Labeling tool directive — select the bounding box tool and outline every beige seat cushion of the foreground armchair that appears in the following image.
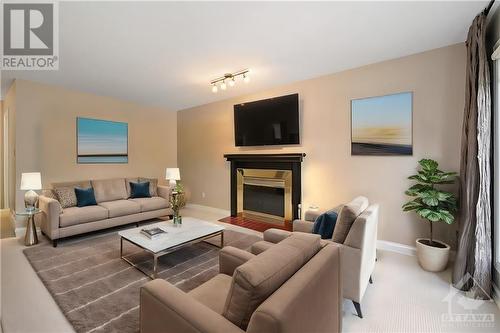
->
[189,274,233,314]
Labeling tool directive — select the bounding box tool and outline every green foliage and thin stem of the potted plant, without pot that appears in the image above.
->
[402,159,457,246]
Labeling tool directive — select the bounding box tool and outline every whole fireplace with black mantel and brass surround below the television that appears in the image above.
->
[224,153,305,222]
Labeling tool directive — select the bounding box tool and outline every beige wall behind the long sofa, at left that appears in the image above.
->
[16,80,177,209]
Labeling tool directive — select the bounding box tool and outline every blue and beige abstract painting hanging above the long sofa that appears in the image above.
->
[76,118,128,164]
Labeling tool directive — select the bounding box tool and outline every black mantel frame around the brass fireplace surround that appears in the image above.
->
[224,153,306,220]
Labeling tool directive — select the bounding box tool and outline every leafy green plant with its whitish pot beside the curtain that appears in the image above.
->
[402,159,457,272]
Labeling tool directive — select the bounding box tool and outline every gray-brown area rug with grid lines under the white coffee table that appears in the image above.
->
[24,223,260,332]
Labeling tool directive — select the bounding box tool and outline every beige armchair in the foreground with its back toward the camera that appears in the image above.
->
[140,233,342,333]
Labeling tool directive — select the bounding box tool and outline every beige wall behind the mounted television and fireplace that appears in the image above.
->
[177,44,465,245]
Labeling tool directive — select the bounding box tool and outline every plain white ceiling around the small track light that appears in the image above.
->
[1,1,487,111]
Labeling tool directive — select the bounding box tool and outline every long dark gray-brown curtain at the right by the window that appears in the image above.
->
[453,12,492,299]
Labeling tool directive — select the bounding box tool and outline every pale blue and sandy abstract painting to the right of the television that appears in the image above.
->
[351,92,413,155]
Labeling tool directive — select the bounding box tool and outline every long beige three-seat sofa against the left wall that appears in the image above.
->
[37,178,173,247]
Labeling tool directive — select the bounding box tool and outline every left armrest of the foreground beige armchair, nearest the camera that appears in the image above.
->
[140,279,243,333]
